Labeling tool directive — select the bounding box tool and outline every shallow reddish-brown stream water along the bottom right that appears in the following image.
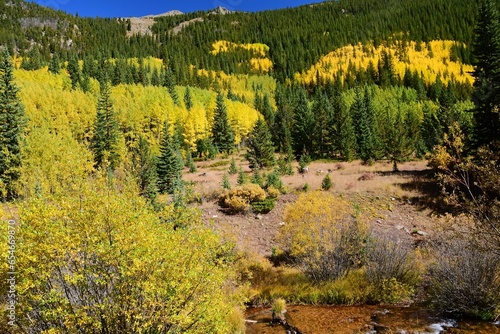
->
[246,305,500,334]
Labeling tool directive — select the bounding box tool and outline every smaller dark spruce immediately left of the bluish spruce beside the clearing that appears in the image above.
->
[132,136,158,203]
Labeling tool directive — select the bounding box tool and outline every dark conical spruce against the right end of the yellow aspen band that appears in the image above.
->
[211,92,234,153]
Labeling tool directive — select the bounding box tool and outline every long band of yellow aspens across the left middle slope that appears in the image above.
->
[15,68,260,156]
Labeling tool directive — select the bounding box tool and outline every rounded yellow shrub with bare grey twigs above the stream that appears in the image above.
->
[277,191,366,282]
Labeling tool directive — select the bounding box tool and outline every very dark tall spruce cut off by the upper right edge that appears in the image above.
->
[473,0,500,148]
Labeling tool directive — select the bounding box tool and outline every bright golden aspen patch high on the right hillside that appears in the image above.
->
[295,40,474,84]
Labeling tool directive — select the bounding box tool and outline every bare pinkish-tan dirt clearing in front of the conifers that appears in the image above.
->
[184,156,434,256]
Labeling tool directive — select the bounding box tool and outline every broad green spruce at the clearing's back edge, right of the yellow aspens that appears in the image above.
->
[246,118,275,169]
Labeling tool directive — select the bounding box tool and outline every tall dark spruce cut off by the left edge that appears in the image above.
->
[0,48,26,199]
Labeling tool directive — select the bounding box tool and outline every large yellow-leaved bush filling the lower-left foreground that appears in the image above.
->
[11,175,241,333]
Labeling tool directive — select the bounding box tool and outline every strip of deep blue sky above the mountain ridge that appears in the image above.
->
[31,0,321,17]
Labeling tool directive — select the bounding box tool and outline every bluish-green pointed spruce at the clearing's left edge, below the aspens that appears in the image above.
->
[156,121,182,194]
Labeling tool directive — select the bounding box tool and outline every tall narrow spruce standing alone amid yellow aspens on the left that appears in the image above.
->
[90,82,120,170]
